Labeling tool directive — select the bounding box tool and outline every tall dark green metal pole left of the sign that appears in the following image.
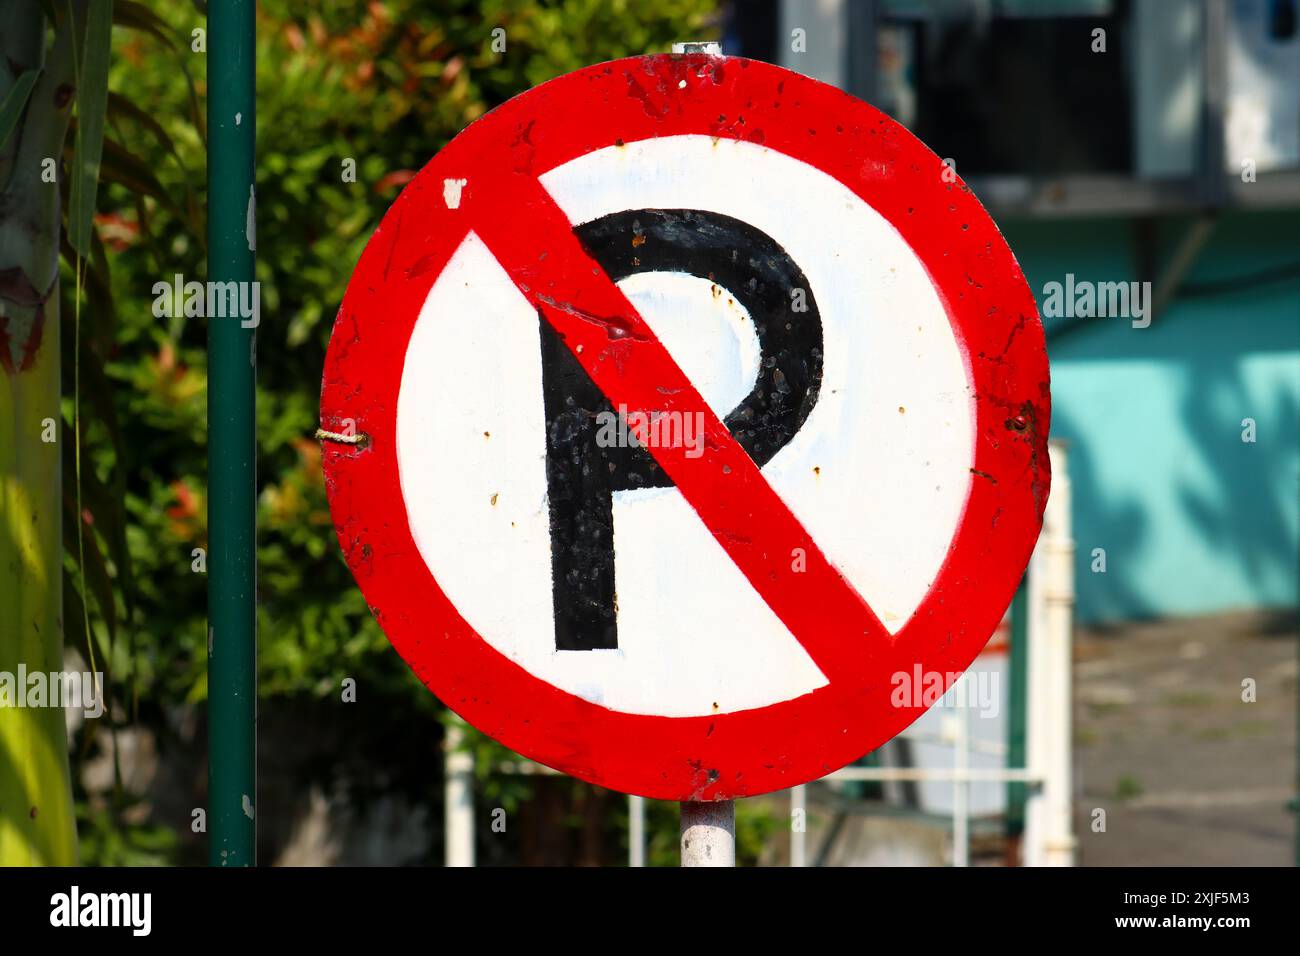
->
[208,0,257,866]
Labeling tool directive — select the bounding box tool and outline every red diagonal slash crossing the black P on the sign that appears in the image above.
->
[473,176,892,684]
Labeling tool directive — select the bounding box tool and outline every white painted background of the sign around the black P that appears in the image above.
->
[397,135,974,717]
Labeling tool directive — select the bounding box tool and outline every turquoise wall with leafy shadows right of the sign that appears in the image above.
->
[1002,212,1300,622]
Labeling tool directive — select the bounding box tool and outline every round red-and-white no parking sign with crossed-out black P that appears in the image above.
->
[321,55,1049,800]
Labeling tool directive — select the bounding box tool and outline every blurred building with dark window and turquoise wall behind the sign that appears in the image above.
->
[724,0,1300,622]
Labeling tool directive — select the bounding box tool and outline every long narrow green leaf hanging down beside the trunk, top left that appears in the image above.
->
[68,0,113,259]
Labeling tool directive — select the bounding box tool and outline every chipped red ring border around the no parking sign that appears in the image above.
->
[321,55,1050,800]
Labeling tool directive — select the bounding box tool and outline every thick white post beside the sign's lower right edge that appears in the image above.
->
[1024,442,1075,866]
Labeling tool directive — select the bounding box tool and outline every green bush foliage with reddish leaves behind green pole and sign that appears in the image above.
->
[64,0,790,864]
